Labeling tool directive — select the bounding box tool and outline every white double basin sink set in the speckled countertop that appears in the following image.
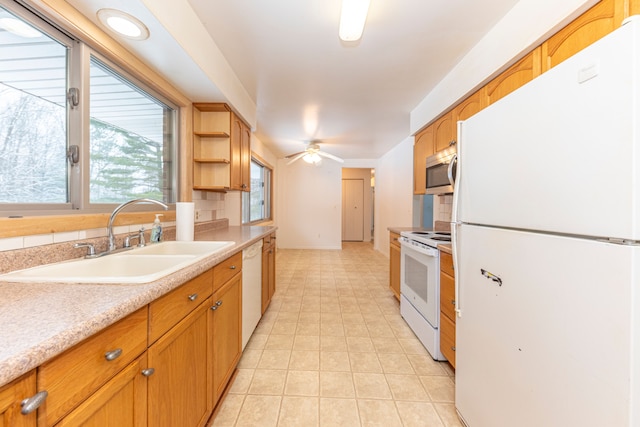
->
[0,241,235,284]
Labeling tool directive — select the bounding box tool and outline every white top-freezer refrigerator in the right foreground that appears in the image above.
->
[452,18,640,427]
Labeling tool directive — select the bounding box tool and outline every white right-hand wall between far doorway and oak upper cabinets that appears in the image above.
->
[374,137,413,256]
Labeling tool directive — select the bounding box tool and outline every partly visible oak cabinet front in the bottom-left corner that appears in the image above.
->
[0,371,36,427]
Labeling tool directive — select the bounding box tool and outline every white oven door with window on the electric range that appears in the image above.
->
[400,240,440,329]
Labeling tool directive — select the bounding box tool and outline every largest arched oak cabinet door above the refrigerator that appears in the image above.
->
[542,0,624,71]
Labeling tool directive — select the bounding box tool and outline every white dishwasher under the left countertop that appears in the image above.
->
[242,239,262,350]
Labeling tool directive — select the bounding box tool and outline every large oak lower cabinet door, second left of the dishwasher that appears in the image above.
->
[148,298,213,427]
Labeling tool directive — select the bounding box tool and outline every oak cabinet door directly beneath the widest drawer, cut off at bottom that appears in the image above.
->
[56,353,147,427]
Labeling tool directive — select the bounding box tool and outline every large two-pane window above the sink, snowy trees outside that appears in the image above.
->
[0,0,177,216]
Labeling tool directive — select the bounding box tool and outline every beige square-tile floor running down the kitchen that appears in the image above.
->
[211,243,461,427]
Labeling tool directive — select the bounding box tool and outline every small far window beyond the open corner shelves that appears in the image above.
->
[242,156,272,224]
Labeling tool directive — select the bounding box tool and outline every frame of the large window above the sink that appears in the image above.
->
[0,0,180,217]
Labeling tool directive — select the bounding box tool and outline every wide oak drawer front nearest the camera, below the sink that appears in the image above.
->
[38,306,147,426]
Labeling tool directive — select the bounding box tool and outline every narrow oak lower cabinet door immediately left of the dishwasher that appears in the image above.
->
[212,274,242,402]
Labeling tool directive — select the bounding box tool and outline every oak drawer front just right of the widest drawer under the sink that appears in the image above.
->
[149,270,213,343]
